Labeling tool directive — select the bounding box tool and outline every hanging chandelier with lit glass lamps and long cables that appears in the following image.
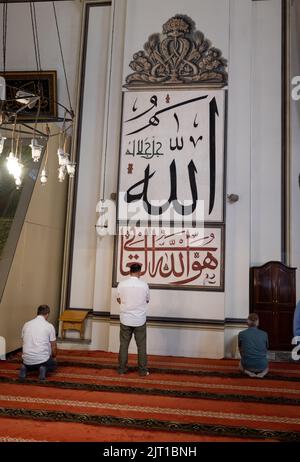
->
[0,2,76,189]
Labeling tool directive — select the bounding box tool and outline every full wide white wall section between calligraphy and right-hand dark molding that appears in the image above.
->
[225,0,281,319]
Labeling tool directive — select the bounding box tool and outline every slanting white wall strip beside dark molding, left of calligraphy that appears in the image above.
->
[70,6,111,308]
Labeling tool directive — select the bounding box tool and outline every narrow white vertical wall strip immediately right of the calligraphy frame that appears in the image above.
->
[225,0,253,318]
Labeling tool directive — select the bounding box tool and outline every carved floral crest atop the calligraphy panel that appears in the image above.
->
[126,15,227,86]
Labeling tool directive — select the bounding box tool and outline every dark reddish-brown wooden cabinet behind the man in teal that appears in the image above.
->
[250,261,296,350]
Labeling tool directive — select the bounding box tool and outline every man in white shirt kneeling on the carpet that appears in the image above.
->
[19,305,57,381]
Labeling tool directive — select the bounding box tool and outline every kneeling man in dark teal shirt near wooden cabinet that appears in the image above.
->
[238,313,269,378]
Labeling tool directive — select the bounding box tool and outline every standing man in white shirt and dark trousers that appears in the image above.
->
[117,263,150,376]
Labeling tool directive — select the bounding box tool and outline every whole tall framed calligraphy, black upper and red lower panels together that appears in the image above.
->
[114,88,226,291]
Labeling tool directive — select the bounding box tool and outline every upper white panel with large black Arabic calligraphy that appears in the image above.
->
[118,89,225,223]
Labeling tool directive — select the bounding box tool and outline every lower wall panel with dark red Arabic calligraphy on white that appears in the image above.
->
[115,225,224,291]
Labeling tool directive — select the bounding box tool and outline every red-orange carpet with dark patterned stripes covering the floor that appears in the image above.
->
[0,350,300,442]
